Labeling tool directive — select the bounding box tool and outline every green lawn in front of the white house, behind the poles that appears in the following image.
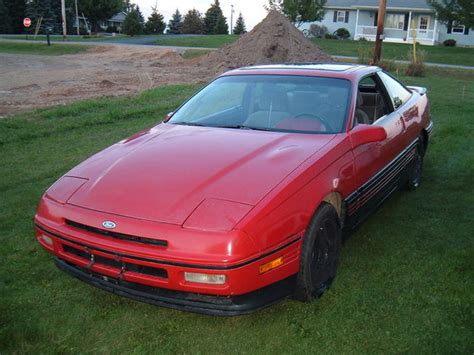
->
[312,38,474,66]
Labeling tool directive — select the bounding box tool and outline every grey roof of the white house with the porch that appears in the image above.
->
[326,0,434,12]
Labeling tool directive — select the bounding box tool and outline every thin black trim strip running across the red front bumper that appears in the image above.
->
[35,223,301,270]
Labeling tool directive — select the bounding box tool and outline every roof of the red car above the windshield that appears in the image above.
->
[222,63,381,80]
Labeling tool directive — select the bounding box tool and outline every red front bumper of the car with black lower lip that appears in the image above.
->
[35,207,301,316]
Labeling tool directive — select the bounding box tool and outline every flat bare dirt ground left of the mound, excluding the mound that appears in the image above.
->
[0,45,214,116]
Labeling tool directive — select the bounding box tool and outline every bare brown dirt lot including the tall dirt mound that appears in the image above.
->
[0,12,333,117]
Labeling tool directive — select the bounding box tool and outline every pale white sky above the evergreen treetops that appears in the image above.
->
[134,0,268,31]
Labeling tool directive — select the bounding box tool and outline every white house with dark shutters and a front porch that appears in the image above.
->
[301,0,474,46]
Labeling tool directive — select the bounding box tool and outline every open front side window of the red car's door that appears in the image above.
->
[354,75,390,126]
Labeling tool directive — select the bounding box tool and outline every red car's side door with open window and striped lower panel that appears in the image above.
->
[348,74,405,225]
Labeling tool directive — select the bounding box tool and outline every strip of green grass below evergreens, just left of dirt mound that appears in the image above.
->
[155,35,239,48]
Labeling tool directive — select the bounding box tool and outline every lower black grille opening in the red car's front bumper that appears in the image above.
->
[63,244,168,279]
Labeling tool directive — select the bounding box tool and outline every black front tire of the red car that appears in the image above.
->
[295,203,342,302]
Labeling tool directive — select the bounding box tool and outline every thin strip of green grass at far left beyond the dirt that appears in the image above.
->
[0,41,91,55]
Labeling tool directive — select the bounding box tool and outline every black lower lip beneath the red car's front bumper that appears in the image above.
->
[55,258,296,316]
